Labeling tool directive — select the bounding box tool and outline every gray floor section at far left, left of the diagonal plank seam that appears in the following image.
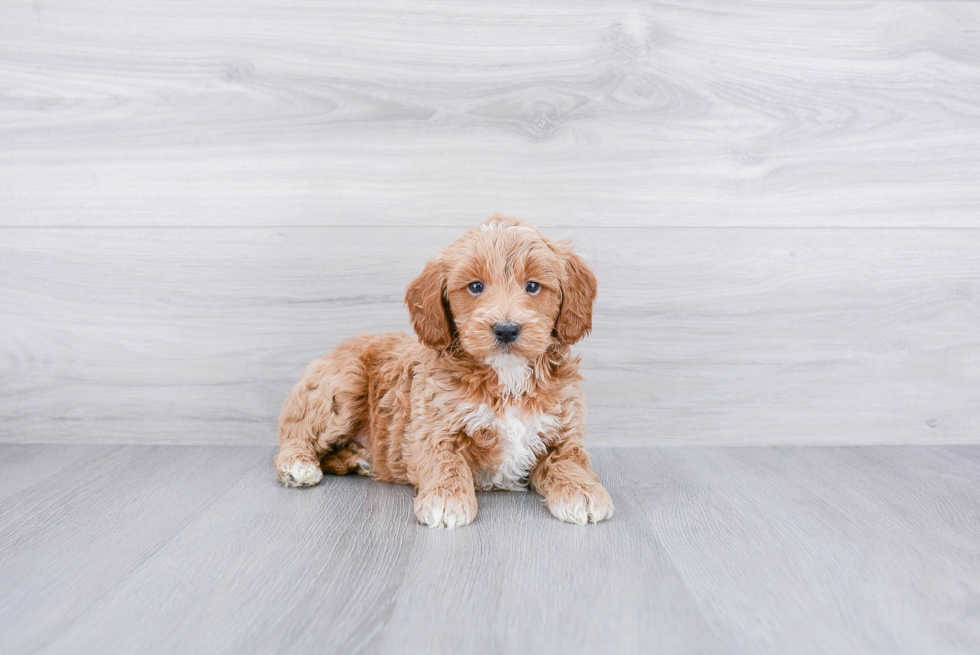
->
[0,446,268,653]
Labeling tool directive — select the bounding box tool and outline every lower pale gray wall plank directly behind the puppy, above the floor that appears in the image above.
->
[0,228,980,445]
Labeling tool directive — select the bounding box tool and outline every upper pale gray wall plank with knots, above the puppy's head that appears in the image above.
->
[0,0,980,227]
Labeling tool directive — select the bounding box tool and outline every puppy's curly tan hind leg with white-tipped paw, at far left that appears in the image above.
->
[275,342,367,487]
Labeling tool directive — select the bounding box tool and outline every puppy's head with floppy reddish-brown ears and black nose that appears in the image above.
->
[405,215,596,362]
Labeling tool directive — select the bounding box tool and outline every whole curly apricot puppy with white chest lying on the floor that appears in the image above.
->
[275,214,613,528]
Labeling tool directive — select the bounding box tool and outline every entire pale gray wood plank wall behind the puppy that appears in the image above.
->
[0,0,980,445]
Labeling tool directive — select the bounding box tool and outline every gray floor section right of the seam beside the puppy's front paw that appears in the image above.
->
[615,448,980,653]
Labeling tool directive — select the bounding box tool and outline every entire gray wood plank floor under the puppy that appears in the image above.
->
[0,445,980,655]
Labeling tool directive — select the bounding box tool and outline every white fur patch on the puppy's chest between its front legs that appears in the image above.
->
[464,405,558,491]
